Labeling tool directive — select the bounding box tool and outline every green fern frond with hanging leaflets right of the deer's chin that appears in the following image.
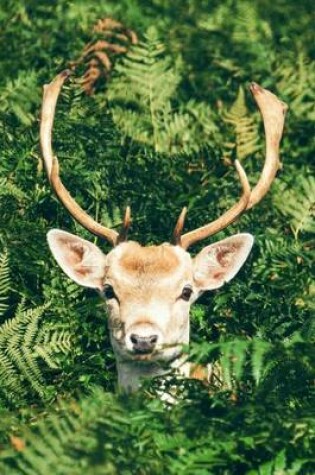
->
[189,333,315,402]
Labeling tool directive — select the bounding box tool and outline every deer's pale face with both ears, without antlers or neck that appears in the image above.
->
[48,230,253,362]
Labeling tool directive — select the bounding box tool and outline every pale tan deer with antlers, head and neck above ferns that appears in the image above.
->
[40,71,287,392]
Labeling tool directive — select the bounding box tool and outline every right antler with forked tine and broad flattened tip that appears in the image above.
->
[178,83,288,249]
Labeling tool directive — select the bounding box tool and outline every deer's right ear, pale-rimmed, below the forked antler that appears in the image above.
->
[193,234,254,292]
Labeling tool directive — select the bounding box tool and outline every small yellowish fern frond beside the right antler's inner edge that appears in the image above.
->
[223,87,259,164]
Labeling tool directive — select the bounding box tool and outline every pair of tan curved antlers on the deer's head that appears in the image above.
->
[40,71,287,249]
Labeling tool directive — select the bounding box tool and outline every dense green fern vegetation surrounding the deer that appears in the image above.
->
[0,0,315,475]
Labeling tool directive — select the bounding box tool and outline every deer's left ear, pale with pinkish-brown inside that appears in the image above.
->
[47,229,106,290]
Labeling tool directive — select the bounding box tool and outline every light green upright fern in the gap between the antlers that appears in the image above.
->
[108,28,216,153]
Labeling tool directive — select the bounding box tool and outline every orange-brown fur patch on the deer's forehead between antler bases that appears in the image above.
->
[120,243,180,274]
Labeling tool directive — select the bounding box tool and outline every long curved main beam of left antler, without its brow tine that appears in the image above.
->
[40,71,119,246]
